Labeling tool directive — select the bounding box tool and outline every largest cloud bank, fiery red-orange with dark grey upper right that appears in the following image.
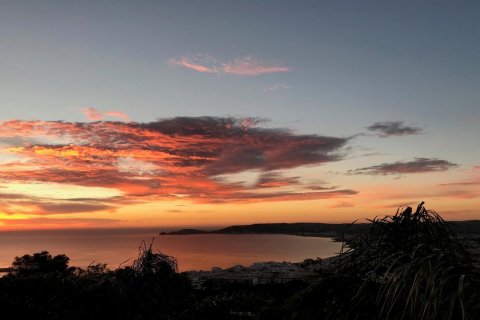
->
[0,117,356,214]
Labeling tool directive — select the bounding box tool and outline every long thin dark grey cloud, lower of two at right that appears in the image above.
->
[349,158,458,175]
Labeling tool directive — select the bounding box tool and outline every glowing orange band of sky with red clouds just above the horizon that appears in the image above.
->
[0,117,480,230]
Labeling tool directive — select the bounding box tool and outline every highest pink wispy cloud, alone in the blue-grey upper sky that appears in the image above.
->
[169,55,291,76]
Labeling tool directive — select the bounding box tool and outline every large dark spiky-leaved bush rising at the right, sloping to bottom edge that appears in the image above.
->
[283,202,480,320]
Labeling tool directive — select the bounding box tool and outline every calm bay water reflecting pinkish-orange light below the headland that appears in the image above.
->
[0,229,341,271]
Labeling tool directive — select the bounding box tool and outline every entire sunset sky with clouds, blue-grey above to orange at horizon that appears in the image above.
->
[0,0,480,230]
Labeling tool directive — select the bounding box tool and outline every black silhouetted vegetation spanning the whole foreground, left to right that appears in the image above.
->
[0,203,480,320]
